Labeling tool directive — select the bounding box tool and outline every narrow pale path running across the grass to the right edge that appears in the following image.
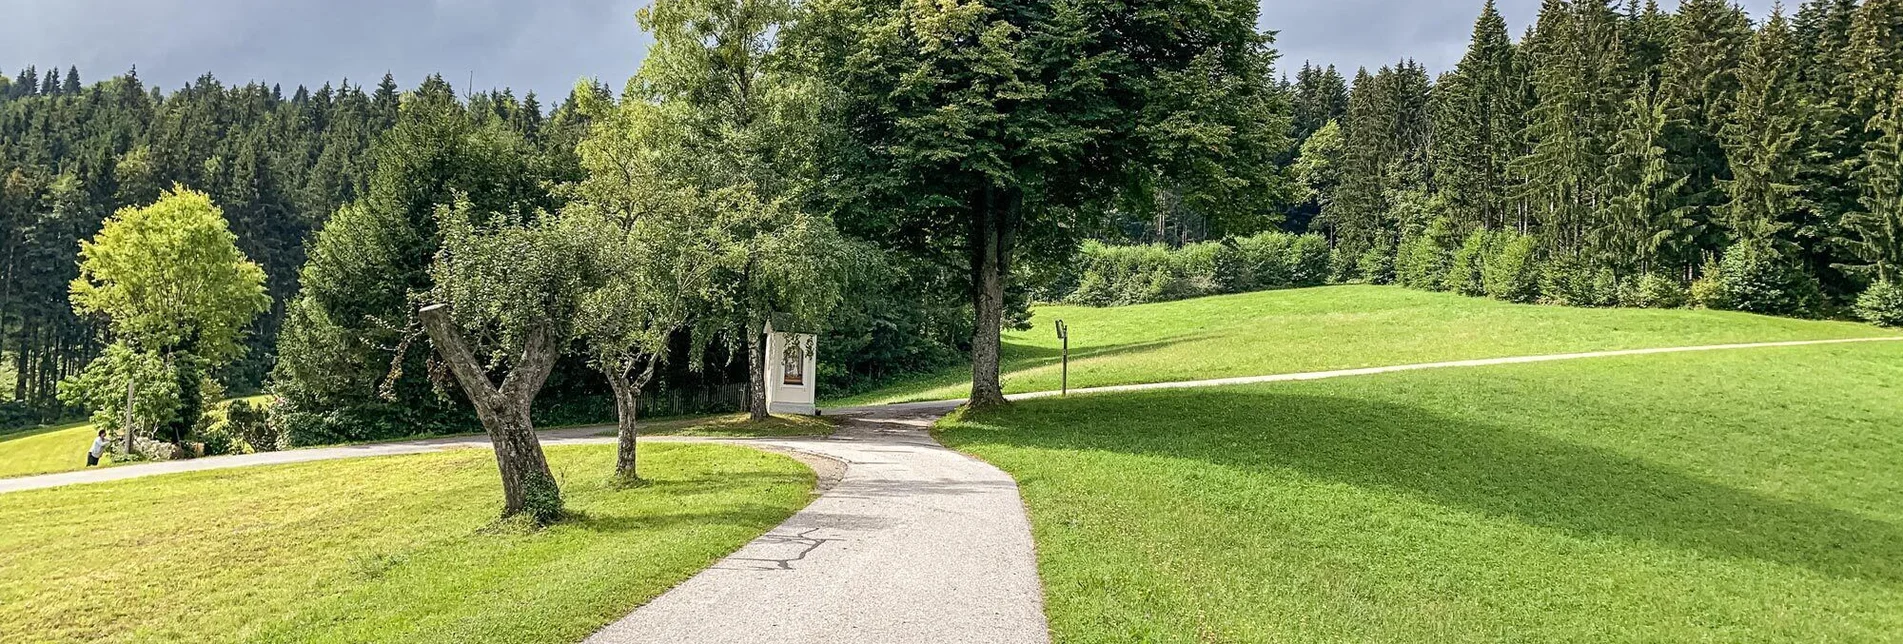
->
[824,335,1903,415]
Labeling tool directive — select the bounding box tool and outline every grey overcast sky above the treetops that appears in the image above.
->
[0,0,1796,105]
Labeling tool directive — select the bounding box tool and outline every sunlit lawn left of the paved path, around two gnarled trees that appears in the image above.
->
[0,444,813,642]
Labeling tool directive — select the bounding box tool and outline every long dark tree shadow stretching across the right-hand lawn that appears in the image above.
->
[946,391,1903,583]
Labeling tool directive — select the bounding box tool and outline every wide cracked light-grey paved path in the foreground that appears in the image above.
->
[586,406,1049,644]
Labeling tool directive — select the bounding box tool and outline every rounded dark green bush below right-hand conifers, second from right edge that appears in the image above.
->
[1694,242,1823,316]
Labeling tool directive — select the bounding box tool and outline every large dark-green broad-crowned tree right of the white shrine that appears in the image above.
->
[794,0,1288,406]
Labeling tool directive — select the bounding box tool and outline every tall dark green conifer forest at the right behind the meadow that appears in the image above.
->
[1286,0,1903,314]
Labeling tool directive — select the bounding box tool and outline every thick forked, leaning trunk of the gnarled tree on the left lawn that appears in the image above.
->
[421,305,561,522]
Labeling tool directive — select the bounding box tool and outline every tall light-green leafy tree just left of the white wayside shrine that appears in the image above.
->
[627,0,843,421]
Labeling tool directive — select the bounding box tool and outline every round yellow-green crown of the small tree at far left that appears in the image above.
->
[72,189,270,366]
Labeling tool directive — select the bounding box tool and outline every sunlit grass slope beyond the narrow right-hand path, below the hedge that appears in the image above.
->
[826,286,1895,406]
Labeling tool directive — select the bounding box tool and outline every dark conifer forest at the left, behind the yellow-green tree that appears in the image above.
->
[0,67,586,423]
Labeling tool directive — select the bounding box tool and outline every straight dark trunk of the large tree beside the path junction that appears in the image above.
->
[969,187,1018,408]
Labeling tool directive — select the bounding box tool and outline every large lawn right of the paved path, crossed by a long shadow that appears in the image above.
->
[940,337,1903,642]
